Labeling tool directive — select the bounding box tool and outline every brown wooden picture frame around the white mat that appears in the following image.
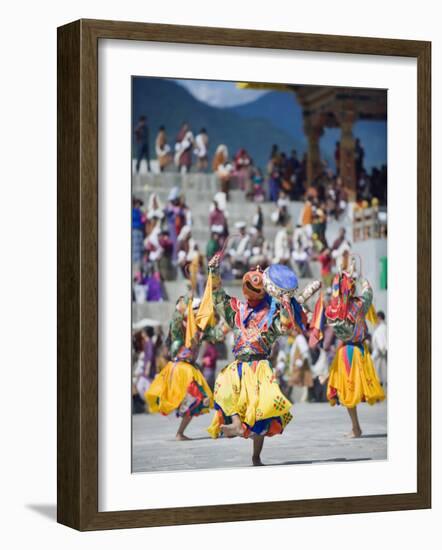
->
[57,20,431,531]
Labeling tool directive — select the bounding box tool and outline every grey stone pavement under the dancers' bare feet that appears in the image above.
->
[132,402,387,472]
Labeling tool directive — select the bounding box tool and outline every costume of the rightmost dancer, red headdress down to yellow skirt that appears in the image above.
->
[325,273,385,408]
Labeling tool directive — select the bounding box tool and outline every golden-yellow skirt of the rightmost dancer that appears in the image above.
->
[327,344,385,409]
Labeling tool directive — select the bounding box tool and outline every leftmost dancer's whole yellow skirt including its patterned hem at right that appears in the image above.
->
[145,361,213,416]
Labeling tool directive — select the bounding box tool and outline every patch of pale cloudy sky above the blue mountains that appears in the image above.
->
[175,80,267,107]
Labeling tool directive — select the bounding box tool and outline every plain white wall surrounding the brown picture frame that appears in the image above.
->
[0,0,442,550]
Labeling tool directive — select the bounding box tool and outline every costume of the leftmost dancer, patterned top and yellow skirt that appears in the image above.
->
[145,297,214,417]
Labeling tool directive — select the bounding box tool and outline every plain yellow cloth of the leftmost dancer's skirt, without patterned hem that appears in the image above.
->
[145,361,213,414]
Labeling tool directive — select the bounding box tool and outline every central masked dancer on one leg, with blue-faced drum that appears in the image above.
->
[203,253,322,466]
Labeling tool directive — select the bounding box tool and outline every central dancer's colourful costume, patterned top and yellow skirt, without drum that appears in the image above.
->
[208,267,302,438]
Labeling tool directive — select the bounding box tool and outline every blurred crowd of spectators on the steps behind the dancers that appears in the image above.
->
[132,119,387,410]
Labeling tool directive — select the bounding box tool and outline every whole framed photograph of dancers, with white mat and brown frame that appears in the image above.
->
[57,20,431,530]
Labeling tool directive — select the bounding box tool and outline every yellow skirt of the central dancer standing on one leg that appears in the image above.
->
[207,360,293,438]
